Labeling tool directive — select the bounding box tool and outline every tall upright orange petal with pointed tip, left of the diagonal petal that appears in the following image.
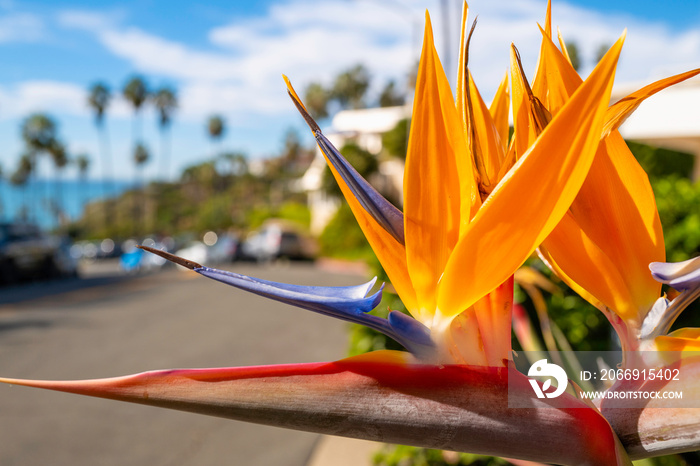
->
[404,15,470,313]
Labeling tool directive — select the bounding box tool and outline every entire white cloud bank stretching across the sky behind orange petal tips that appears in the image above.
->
[53,0,700,127]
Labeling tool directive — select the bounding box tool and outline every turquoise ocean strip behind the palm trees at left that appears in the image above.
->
[0,179,133,230]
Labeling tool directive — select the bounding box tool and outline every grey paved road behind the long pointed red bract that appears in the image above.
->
[0,264,361,466]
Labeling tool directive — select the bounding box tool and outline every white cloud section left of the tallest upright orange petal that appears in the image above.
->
[60,0,417,118]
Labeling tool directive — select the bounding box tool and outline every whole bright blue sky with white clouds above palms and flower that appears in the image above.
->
[0,0,700,179]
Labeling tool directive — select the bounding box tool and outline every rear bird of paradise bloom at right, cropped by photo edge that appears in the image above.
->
[514,6,700,447]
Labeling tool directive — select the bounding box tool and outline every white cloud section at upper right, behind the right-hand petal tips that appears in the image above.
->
[448,0,700,94]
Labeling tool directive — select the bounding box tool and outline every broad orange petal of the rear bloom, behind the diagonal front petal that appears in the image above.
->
[543,131,665,326]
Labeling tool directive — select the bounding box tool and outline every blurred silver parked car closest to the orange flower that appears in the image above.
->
[241,221,318,262]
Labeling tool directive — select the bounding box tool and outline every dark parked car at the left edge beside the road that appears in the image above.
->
[0,222,77,284]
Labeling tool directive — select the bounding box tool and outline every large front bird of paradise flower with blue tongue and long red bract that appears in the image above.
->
[2,1,700,464]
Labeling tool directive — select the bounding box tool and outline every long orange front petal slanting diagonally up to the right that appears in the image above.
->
[438,31,623,318]
